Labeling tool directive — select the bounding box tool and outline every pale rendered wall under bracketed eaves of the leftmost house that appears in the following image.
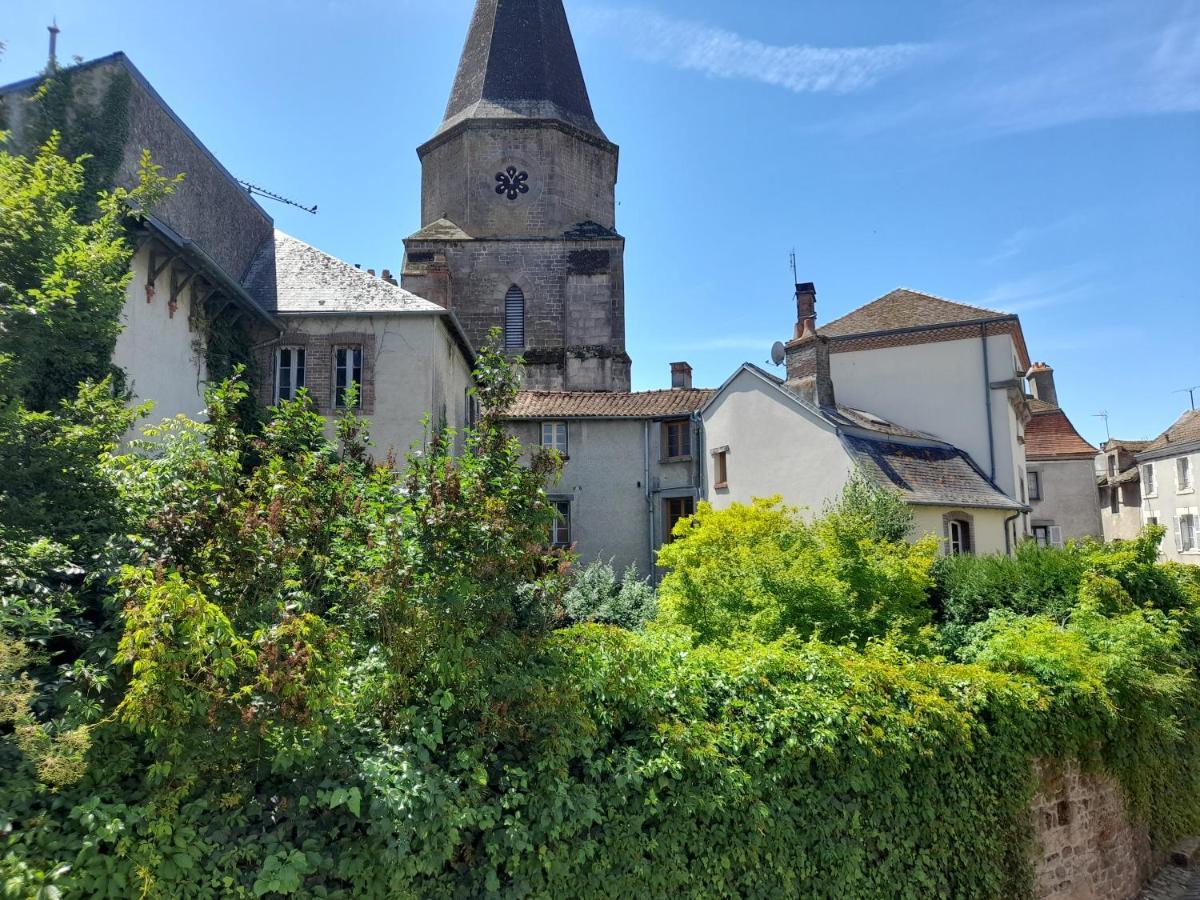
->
[113,246,208,432]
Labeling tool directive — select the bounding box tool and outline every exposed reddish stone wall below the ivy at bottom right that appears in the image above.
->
[1032,761,1154,900]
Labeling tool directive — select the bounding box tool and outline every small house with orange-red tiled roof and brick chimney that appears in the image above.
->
[1025,362,1103,547]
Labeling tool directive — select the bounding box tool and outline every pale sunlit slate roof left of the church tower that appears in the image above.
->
[244,229,445,314]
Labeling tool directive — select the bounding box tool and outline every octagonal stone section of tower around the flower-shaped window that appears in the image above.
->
[421,121,617,238]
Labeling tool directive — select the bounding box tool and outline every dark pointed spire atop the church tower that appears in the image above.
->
[438,0,607,140]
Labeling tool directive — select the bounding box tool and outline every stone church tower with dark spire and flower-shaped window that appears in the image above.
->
[403,0,630,391]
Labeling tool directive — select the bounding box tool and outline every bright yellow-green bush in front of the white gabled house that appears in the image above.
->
[659,488,937,646]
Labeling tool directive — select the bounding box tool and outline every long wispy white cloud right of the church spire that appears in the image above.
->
[580,7,929,94]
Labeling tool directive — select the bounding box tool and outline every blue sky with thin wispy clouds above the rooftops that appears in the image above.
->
[0,0,1200,442]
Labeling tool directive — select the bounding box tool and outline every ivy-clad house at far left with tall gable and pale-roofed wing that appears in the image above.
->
[0,53,474,457]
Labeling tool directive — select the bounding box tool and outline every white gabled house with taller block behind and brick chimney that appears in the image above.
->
[701,283,1028,553]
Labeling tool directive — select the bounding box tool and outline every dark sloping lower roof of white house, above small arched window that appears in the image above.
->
[842,436,1025,511]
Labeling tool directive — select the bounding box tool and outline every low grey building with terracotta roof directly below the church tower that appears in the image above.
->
[509,362,713,578]
